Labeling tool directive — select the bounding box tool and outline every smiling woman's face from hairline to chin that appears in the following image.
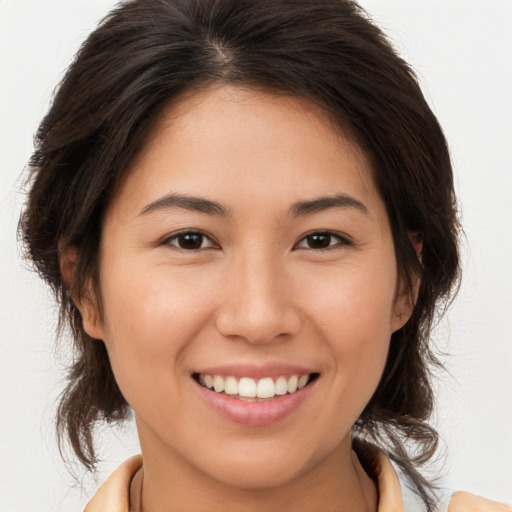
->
[84,86,407,487]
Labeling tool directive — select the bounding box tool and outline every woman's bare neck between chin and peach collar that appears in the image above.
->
[130,436,378,512]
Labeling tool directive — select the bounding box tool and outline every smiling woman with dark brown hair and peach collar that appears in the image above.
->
[18,0,510,512]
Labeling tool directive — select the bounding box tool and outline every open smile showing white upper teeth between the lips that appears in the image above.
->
[192,373,320,402]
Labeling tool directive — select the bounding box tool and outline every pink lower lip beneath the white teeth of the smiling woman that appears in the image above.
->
[193,380,316,427]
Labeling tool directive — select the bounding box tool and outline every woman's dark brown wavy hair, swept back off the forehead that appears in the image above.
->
[20,0,459,510]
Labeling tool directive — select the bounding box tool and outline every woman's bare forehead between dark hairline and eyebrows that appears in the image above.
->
[111,85,377,217]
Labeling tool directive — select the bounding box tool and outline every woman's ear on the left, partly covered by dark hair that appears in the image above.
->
[60,247,104,339]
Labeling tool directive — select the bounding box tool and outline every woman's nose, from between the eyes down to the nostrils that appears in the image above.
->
[216,249,301,344]
